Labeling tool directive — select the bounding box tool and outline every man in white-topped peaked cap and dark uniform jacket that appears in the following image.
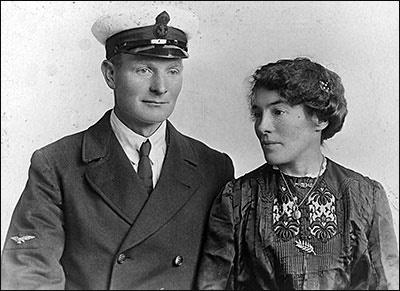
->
[2,7,233,289]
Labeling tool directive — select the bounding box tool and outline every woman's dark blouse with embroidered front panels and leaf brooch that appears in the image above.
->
[197,158,399,290]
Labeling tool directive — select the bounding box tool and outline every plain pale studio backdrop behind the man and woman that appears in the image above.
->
[1,1,399,248]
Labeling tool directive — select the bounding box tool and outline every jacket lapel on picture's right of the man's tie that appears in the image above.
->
[120,121,202,251]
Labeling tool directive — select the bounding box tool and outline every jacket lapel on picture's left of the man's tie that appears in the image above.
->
[82,111,147,224]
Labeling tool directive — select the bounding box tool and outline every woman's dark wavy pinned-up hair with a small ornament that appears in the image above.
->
[248,58,347,142]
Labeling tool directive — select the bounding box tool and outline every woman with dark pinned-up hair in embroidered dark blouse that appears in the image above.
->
[198,58,398,290]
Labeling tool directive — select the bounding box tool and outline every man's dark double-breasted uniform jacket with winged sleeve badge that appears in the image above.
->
[1,111,233,290]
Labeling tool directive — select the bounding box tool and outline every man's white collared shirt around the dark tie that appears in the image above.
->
[110,109,167,187]
